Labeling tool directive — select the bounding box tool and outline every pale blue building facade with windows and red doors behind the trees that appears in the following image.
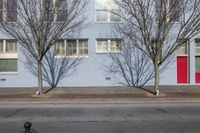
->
[0,0,200,88]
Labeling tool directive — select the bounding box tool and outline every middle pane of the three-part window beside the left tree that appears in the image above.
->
[67,40,77,56]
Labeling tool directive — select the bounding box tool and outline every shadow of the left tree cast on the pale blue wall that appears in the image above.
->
[23,49,83,90]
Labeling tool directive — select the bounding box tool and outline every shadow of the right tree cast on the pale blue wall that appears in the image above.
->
[104,40,154,88]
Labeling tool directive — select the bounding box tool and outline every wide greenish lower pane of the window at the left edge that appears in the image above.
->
[0,59,17,72]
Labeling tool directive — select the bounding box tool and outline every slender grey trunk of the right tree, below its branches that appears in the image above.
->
[154,62,160,96]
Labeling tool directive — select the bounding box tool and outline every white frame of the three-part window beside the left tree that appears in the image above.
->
[56,39,89,58]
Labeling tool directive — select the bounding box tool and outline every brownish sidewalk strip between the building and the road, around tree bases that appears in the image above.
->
[0,86,200,102]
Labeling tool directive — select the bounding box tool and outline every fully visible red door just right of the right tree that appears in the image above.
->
[177,56,188,83]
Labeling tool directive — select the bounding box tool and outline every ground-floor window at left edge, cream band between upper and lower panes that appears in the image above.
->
[0,40,17,72]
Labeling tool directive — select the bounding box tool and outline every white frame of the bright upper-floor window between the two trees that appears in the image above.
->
[95,0,122,23]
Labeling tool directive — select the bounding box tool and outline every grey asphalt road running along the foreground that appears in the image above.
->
[0,103,200,133]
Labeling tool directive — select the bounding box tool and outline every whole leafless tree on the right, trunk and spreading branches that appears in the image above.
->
[110,0,200,95]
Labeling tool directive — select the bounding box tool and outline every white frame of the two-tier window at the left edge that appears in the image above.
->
[0,39,18,74]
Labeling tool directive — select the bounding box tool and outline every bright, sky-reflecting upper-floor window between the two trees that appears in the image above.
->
[96,0,121,22]
